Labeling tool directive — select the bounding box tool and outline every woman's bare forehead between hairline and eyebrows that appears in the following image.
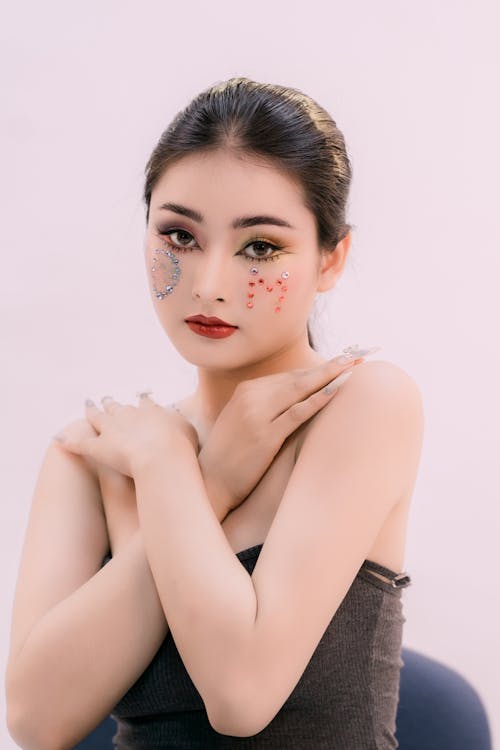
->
[151,151,314,227]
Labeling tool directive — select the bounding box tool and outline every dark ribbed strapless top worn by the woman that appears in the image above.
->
[106,544,411,750]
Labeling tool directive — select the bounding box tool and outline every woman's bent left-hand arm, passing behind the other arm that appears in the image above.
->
[6,420,232,750]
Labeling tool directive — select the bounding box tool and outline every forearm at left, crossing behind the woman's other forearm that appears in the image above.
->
[7,531,168,750]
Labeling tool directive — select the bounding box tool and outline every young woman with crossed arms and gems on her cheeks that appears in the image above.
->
[7,78,423,750]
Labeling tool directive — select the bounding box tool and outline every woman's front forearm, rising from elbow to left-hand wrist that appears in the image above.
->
[133,439,256,717]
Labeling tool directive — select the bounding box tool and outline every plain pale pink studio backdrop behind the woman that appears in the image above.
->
[0,0,500,750]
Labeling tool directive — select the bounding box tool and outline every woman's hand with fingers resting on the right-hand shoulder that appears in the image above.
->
[198,347,379,513]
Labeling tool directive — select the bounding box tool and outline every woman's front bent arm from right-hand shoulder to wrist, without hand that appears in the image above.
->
[133,362,422,736]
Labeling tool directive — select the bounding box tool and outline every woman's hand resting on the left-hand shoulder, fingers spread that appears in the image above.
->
[52,394,198,477]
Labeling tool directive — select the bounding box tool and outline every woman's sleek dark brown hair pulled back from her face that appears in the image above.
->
[143,77,352,349]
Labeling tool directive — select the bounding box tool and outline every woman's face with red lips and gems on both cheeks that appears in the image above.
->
[145,150,328,369]
